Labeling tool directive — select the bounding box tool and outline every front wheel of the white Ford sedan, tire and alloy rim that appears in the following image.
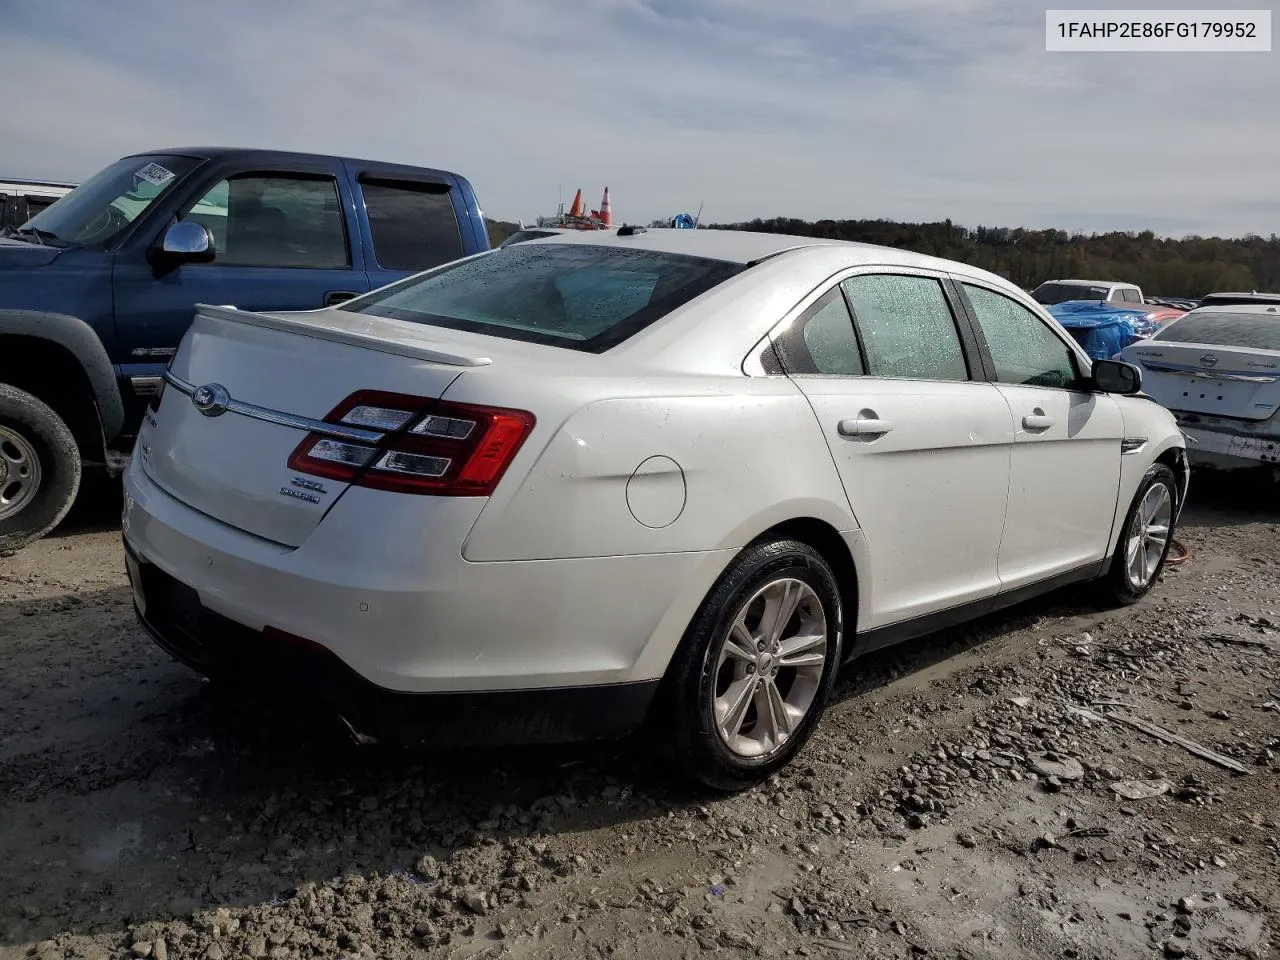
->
[1098,463,1179,607]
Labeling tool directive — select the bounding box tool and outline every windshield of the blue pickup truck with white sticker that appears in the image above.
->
[18,156,200,250]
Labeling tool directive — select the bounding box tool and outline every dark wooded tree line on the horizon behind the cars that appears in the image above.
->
[709,216,1280,297]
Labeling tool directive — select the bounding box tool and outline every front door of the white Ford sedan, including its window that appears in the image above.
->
[957,278,1124,590]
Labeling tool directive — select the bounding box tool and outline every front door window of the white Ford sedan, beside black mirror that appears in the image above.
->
[964,283,1080,389]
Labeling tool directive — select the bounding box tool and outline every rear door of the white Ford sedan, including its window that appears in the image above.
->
[774,270,1014,630]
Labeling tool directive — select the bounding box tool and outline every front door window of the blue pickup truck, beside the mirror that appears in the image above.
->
[183,174,351,269]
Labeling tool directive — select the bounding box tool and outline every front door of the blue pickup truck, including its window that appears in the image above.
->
[114,161,369,401]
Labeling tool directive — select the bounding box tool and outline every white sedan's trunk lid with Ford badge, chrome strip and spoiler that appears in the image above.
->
[138,305,490,547]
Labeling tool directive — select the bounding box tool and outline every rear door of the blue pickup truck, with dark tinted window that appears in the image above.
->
[348,164,466,288]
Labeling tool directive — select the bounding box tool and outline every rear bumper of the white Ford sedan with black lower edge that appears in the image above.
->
[123,460,727,740]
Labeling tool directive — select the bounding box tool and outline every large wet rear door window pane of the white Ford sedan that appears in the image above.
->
[842,274,969,380]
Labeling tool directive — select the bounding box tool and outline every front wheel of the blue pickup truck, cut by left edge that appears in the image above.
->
[0,384,81,550]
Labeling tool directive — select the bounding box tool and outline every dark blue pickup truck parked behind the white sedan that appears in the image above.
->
[0,147,489,550]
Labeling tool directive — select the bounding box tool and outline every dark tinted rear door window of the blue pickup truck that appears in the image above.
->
[360,177,462,271]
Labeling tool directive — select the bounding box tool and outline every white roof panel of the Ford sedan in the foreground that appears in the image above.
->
[519,228,986,273]
